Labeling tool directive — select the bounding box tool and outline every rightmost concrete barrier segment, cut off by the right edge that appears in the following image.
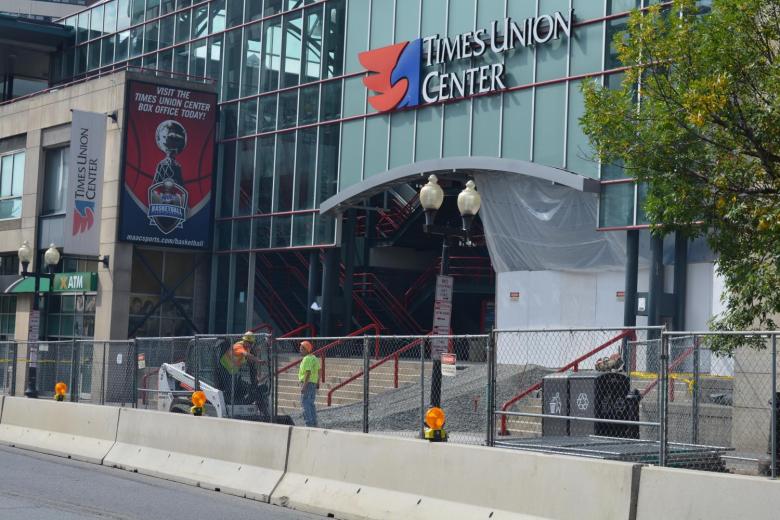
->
[637,466,780,520]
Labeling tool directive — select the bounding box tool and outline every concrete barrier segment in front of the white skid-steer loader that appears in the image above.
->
[104,408,290,502]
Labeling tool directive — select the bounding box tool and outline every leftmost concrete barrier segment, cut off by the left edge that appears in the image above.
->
[0,396,119,464]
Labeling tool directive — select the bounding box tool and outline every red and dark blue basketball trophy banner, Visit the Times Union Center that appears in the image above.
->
[119,81,217,249]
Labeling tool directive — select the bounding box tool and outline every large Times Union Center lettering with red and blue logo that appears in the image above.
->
[358,10,574,112]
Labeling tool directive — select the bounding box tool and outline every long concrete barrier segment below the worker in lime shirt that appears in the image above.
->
[271,428,640,520]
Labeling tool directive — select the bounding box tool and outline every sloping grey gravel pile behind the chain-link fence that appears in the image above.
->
[292,363,549,444]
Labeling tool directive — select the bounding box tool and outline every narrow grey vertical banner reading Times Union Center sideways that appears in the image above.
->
[63,110,106,256]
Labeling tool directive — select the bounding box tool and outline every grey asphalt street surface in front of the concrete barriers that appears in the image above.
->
[0,447,320,520]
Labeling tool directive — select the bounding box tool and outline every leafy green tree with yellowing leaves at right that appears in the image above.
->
[581,0,780,330]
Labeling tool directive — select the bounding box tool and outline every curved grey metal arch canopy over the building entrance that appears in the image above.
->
[320,157,599,214]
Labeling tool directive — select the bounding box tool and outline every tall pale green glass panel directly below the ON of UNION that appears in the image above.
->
[534,84,566,168]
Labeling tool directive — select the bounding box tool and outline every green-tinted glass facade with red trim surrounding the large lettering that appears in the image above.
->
[48,0,672,334]
